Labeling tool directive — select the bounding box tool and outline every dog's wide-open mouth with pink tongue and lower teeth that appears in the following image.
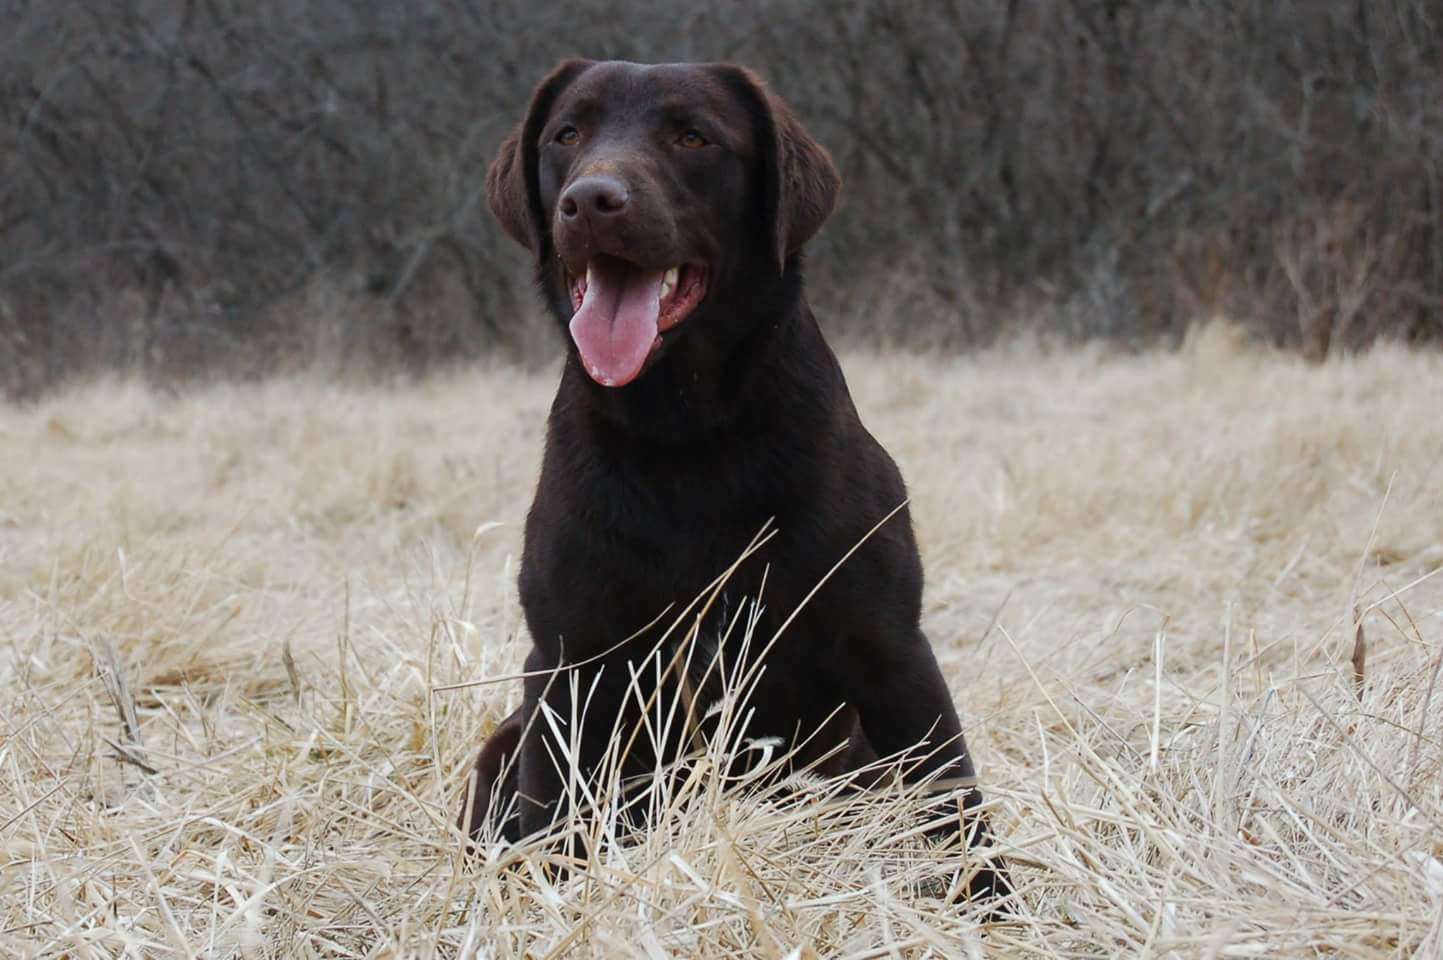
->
[567,256,707,387]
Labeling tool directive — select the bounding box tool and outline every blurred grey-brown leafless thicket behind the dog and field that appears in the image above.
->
[0,0,1443,398]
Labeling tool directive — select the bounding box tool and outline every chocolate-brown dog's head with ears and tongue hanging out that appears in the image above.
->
[486,61,840,387]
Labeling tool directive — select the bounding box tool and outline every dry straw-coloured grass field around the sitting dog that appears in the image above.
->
[0,331,1443,959]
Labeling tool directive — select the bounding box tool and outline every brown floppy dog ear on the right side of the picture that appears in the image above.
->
[719,64,841,270]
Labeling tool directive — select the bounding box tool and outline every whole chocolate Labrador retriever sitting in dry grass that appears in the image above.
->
[460,61,1006,895]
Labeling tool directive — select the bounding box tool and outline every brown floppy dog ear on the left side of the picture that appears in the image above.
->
[486,61,592,251]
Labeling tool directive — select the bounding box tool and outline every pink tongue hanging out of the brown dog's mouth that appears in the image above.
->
[571,257,662,387]
